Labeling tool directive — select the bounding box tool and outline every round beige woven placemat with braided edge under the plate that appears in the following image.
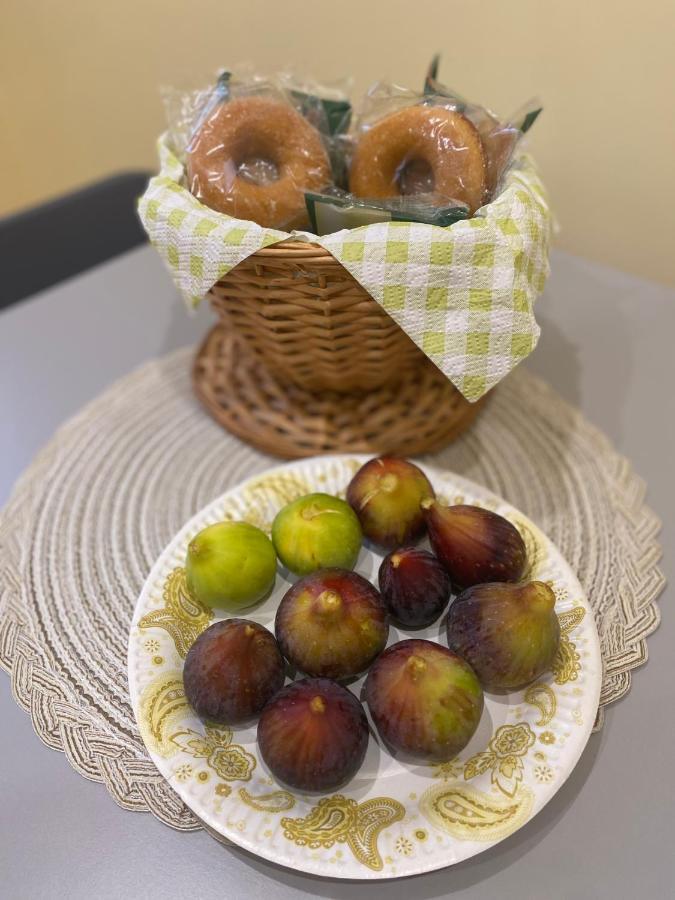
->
[0,350,664,829]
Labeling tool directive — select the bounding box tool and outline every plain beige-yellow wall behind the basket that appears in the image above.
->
[0,0,675,283]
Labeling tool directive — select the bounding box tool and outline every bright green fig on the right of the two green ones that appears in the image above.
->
[272,494,363,575]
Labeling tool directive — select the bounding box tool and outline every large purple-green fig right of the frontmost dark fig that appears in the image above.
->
[365,639,483,762]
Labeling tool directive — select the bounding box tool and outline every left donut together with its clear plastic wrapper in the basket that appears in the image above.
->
[171,72,338,230]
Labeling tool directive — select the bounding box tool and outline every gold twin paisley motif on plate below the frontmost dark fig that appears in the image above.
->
[281,794,405,872]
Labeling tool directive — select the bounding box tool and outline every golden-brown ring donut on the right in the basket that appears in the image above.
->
[349,106,485,214]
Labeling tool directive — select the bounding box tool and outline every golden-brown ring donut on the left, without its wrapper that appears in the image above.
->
[187,96,331,229]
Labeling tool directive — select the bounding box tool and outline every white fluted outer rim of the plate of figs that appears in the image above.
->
[127,453,604,881]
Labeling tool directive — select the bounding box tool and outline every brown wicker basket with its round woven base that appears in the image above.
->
[193,242,488,457]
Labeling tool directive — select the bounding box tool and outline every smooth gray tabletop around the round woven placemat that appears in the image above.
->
[0,247,675,900]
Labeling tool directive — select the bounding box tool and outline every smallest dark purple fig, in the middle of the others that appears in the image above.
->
[378,547,451,628]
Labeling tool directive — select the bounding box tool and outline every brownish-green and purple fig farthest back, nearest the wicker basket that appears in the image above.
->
[347,456,435,550]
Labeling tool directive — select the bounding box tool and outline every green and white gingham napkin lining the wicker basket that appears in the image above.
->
[138,136,552,401]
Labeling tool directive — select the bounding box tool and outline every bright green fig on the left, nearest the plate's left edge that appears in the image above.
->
[185,522,277,612]
